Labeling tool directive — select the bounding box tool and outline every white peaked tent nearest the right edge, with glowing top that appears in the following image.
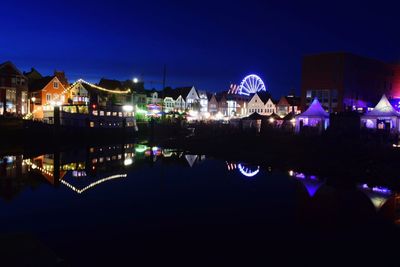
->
[361,95,400,133]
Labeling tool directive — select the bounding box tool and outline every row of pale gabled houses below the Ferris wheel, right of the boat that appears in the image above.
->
[134,86,300,117]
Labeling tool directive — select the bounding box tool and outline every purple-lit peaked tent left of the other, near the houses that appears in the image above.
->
[296,98,329,132]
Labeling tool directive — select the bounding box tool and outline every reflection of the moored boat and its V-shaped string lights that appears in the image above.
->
[24,144,135,194]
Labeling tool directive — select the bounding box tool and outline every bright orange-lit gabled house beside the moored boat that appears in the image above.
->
[28,76,68,119]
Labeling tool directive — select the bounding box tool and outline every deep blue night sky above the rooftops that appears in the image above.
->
[0,0,400,97]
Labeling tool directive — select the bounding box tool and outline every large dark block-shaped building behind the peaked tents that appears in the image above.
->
[301,52,400,112]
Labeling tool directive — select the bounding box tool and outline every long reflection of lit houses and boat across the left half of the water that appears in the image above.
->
[0,146,211,199]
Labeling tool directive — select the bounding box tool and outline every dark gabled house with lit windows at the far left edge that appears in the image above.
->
[0,61,29,115]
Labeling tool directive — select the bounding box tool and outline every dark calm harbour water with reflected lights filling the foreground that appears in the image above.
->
[0,144,400,266]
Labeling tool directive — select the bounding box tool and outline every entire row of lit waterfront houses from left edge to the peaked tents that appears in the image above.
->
[0,61,300,119]
